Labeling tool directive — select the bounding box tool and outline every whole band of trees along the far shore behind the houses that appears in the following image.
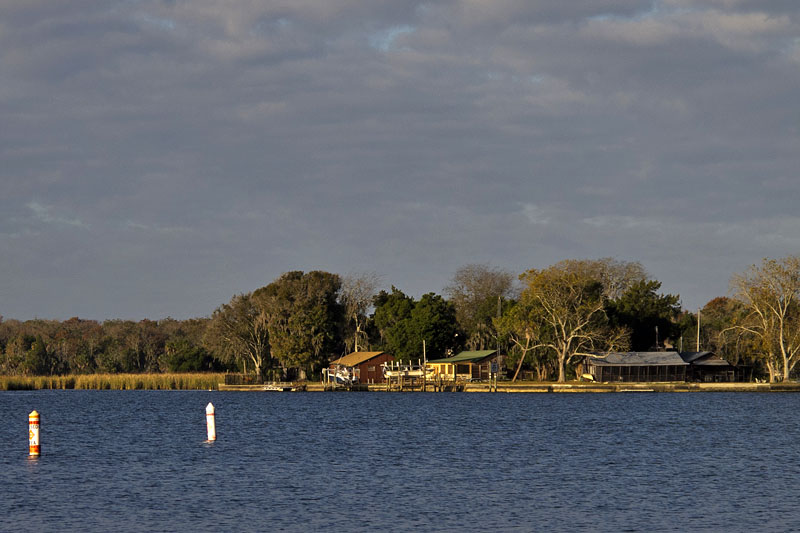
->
[0,256,800,381]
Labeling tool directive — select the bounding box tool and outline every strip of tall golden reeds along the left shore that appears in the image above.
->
[0,373,225,390]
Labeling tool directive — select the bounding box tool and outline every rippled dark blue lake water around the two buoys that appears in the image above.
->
[0,391,800,531]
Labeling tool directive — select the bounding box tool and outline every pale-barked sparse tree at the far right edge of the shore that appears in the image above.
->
[729,256,800,382]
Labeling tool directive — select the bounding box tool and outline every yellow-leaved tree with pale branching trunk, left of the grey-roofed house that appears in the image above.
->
[510,261,626,382]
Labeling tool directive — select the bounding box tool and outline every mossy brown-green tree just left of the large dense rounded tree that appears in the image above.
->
[203,294,271,376]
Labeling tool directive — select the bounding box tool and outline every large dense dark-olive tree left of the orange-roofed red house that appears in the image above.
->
[253,271,343,378]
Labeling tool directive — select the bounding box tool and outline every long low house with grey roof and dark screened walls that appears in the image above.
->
[578,351,691,381]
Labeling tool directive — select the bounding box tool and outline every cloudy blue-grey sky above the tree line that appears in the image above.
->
[0,0,800,320]
